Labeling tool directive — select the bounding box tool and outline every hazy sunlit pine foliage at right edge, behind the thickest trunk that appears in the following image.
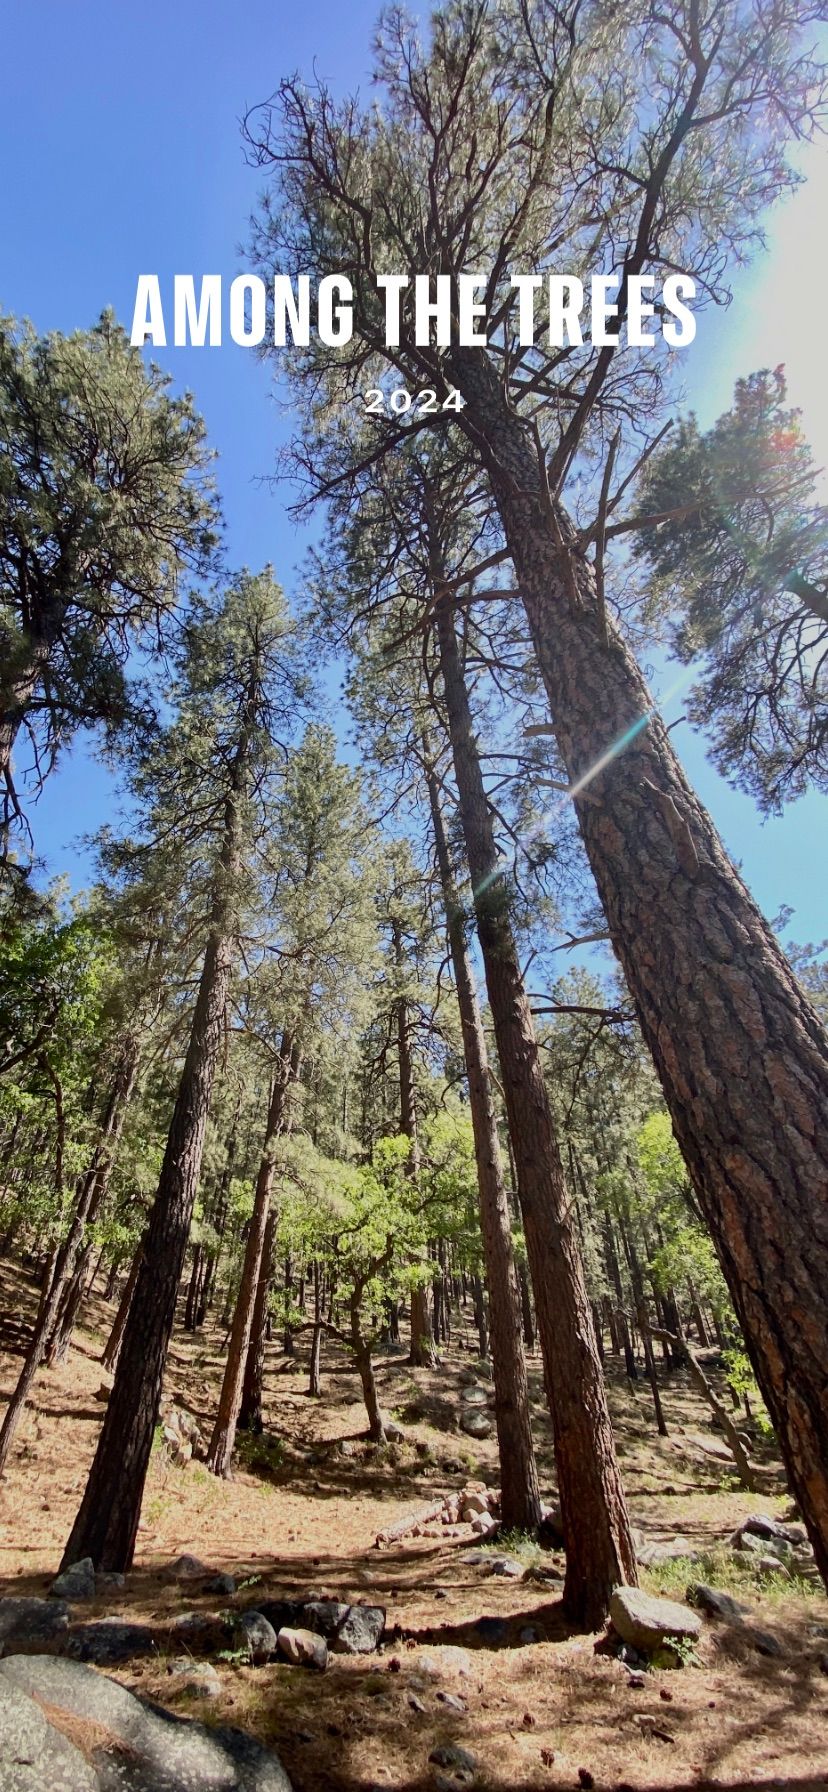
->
[634,367,828,812]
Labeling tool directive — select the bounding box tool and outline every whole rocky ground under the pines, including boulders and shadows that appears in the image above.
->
[0,1271,828,1792]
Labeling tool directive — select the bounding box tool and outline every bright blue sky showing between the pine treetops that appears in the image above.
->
[0,0,828,939]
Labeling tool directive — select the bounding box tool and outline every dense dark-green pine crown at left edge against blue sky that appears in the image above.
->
[0,312,217,824]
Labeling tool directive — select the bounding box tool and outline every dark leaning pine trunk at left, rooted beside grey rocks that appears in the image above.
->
[63,679,258,1572]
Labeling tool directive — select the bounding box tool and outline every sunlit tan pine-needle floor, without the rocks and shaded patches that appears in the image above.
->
[0,1265,828,1792]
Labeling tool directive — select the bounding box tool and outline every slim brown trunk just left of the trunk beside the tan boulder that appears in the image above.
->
[425,744,541,1530]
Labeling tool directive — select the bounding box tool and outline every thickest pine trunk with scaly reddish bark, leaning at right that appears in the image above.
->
[453,349,828,1581]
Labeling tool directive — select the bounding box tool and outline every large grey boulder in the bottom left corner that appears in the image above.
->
[0,1656,290,1792]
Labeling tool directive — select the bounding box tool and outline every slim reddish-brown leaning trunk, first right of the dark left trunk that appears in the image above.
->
[206,1032,299,1475]
